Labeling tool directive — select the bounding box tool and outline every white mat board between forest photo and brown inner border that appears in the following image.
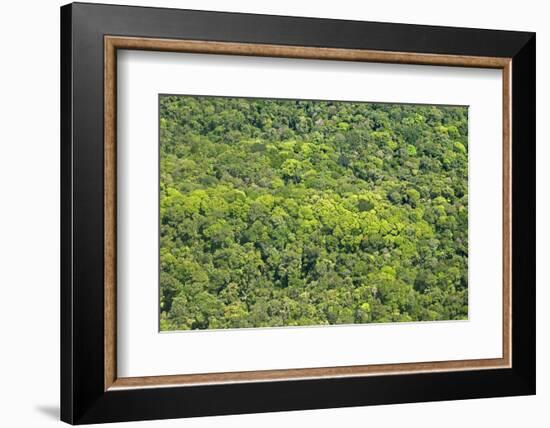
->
[117,51,502,377]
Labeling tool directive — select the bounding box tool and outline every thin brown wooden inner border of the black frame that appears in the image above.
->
[104,36,512,390]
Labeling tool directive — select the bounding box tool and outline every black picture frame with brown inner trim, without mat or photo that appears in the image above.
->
[61,3,535,424]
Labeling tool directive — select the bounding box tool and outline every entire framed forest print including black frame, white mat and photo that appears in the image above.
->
[61,3,535,424]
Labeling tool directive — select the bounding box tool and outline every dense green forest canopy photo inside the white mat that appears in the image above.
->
[160,96,468,330]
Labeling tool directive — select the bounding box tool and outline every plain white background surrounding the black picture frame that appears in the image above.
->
[0,0,550,428]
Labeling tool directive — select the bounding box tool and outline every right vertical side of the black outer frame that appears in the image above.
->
[511,33,536,395]
